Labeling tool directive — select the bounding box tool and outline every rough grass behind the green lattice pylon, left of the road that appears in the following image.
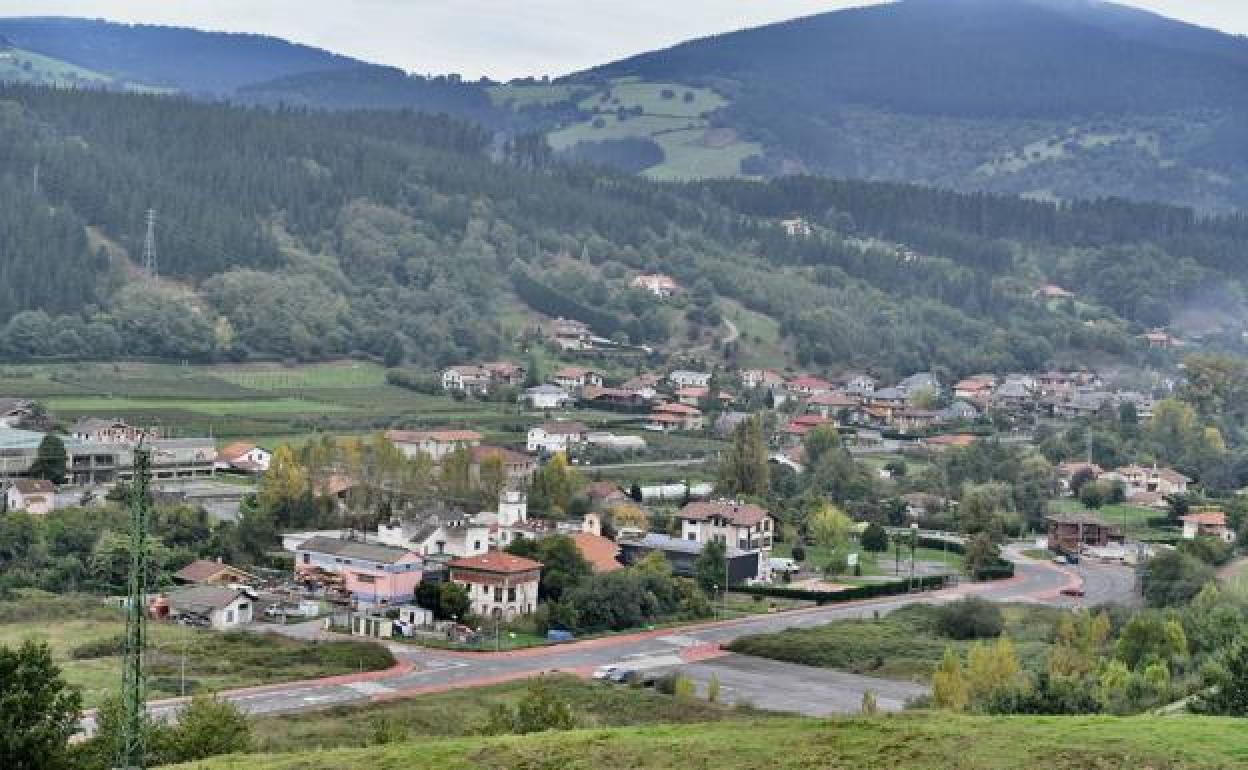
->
[0,597,393,708]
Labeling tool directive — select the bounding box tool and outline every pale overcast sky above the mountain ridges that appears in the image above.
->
[0,0,1248,79]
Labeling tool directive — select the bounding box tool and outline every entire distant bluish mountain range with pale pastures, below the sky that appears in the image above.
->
[7,0,1248,211]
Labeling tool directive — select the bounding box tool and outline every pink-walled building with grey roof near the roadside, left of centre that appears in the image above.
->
[295,537,424,604]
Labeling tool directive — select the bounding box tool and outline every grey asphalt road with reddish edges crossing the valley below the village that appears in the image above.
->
[84,546,1129,731]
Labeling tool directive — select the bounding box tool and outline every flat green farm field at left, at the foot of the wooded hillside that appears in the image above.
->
[0,362,673,452]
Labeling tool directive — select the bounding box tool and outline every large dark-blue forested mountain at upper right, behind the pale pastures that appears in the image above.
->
[570,0,1248,210]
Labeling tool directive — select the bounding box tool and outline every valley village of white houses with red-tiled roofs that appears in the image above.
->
[0,303,1236,648]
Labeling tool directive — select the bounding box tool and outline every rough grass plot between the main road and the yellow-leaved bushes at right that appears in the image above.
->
[729,604,1060,683]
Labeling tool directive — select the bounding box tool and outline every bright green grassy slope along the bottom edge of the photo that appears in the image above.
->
[170,714,1248,770]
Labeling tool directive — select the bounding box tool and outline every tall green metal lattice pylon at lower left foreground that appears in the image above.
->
[117,444,151,770]
